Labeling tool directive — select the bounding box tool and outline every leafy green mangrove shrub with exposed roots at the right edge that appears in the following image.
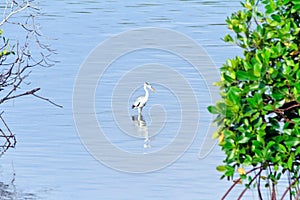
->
[208,0,300,199]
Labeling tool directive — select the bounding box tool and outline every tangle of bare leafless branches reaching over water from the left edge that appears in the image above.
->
[0,0,62,156]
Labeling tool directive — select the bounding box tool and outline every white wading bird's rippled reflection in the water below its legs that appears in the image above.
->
[131,114,152,148]
